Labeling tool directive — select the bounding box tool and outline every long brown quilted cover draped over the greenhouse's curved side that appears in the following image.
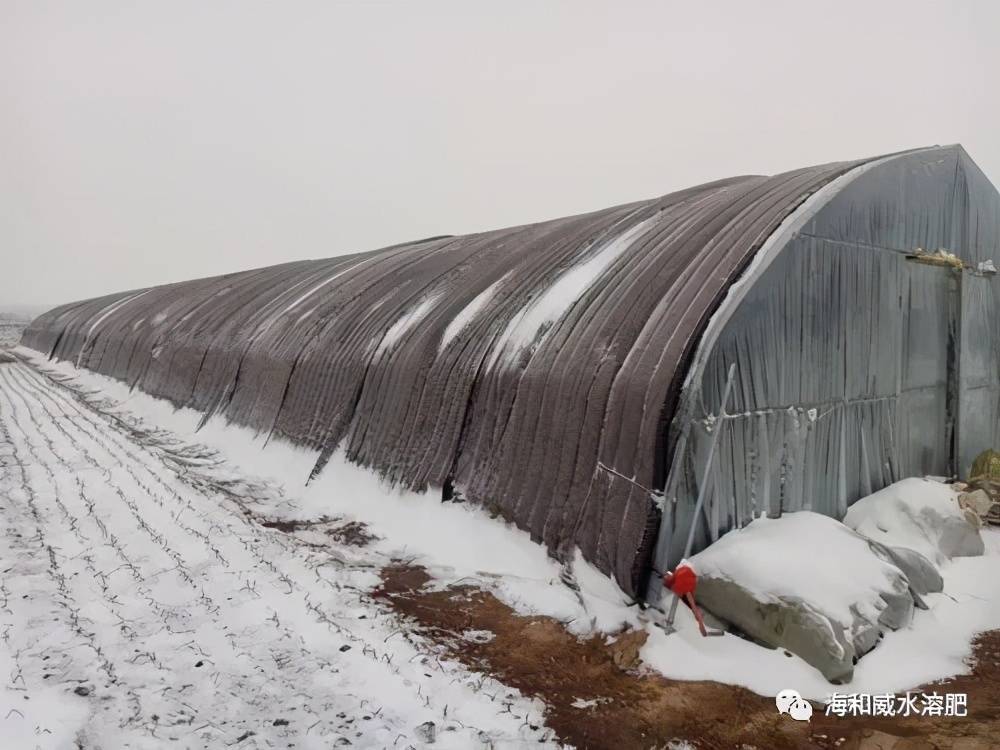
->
[23,162,880,593]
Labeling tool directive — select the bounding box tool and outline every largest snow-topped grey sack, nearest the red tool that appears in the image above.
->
[690,511,914,682]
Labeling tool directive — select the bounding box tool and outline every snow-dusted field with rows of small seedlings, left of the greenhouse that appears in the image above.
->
[0,362,548,748]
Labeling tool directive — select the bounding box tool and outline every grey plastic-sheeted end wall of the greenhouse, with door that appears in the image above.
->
[653,146,1000,592]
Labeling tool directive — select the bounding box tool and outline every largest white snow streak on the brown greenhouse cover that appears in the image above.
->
[490,216,656,367]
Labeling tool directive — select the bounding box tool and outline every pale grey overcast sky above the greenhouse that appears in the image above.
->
[0,0,1000,305]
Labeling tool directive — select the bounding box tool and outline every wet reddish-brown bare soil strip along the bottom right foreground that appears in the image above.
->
[376,564,1000,750]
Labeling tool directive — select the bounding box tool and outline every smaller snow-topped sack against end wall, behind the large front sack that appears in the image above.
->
[844,478,984,565]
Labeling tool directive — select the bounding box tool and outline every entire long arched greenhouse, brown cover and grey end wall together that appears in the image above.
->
[23,147,1000,593]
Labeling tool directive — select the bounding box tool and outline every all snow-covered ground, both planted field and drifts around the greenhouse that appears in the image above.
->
[0,348,1000,747]
